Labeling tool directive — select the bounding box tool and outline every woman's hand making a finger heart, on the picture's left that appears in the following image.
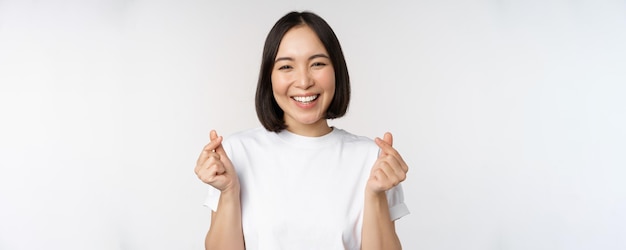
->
[194,130,240,192]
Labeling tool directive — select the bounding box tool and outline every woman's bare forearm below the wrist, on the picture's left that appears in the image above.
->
[205,190,244,250]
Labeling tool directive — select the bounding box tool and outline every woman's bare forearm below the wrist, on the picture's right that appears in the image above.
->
[361,191,402,250]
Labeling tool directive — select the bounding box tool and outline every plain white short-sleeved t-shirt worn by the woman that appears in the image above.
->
[205,128,409,250]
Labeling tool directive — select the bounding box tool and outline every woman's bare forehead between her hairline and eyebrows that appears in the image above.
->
[277,25,327,56]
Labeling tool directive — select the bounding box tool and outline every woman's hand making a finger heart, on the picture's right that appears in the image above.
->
[366,132,409,194]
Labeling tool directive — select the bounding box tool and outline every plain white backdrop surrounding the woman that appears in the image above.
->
[0,0,626,250]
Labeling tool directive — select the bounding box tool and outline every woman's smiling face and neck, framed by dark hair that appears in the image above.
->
[272,25,335,135]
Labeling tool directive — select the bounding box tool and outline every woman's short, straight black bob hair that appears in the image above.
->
[255,12,350,132]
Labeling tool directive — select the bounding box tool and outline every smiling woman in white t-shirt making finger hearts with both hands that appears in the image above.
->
[195,12,409,250]
